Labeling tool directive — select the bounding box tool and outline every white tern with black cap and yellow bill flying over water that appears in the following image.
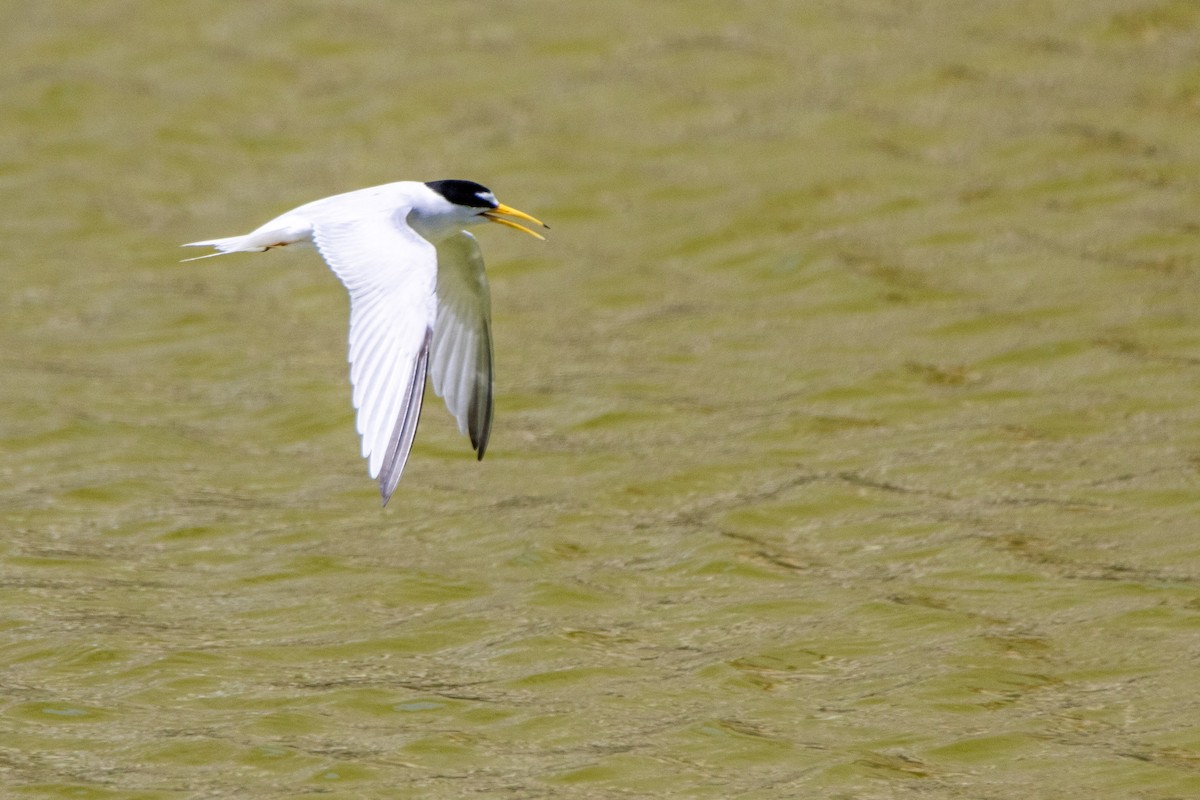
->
[184,180,547,505]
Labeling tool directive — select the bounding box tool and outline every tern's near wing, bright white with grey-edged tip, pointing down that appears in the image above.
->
[313,211,437,505]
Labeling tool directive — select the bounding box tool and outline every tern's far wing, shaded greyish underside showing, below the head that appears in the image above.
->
[430,230,492,458]
